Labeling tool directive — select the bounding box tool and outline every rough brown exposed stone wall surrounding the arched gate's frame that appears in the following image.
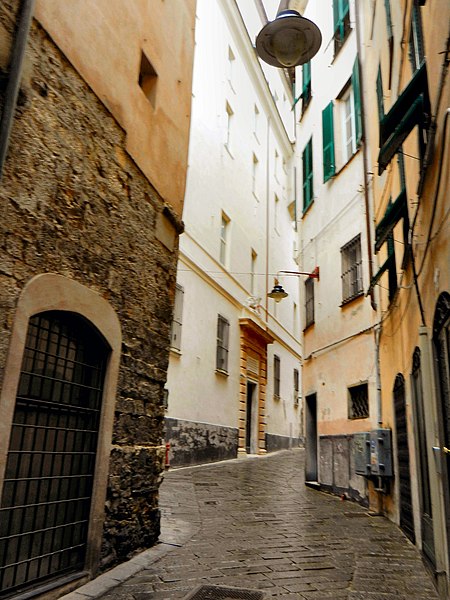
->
[0,0,180,568]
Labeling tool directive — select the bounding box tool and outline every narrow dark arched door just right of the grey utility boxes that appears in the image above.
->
[394,374,415,543]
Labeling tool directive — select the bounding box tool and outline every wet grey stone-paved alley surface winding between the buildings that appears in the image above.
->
[80,449,438,600]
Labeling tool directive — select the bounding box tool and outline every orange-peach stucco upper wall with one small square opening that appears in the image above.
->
[36,0,196,216]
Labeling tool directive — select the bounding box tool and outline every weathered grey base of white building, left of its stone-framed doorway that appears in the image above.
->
[166,417,238,467]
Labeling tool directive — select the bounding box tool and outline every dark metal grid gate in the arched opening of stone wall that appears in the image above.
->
[0,311,108,598]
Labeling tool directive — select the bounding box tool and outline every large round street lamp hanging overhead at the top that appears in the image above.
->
[256,0,322,69]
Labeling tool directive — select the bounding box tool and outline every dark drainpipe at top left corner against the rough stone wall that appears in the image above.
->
[0,0,35,182]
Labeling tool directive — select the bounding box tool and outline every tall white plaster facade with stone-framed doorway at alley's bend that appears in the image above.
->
[167,0,301,436]
